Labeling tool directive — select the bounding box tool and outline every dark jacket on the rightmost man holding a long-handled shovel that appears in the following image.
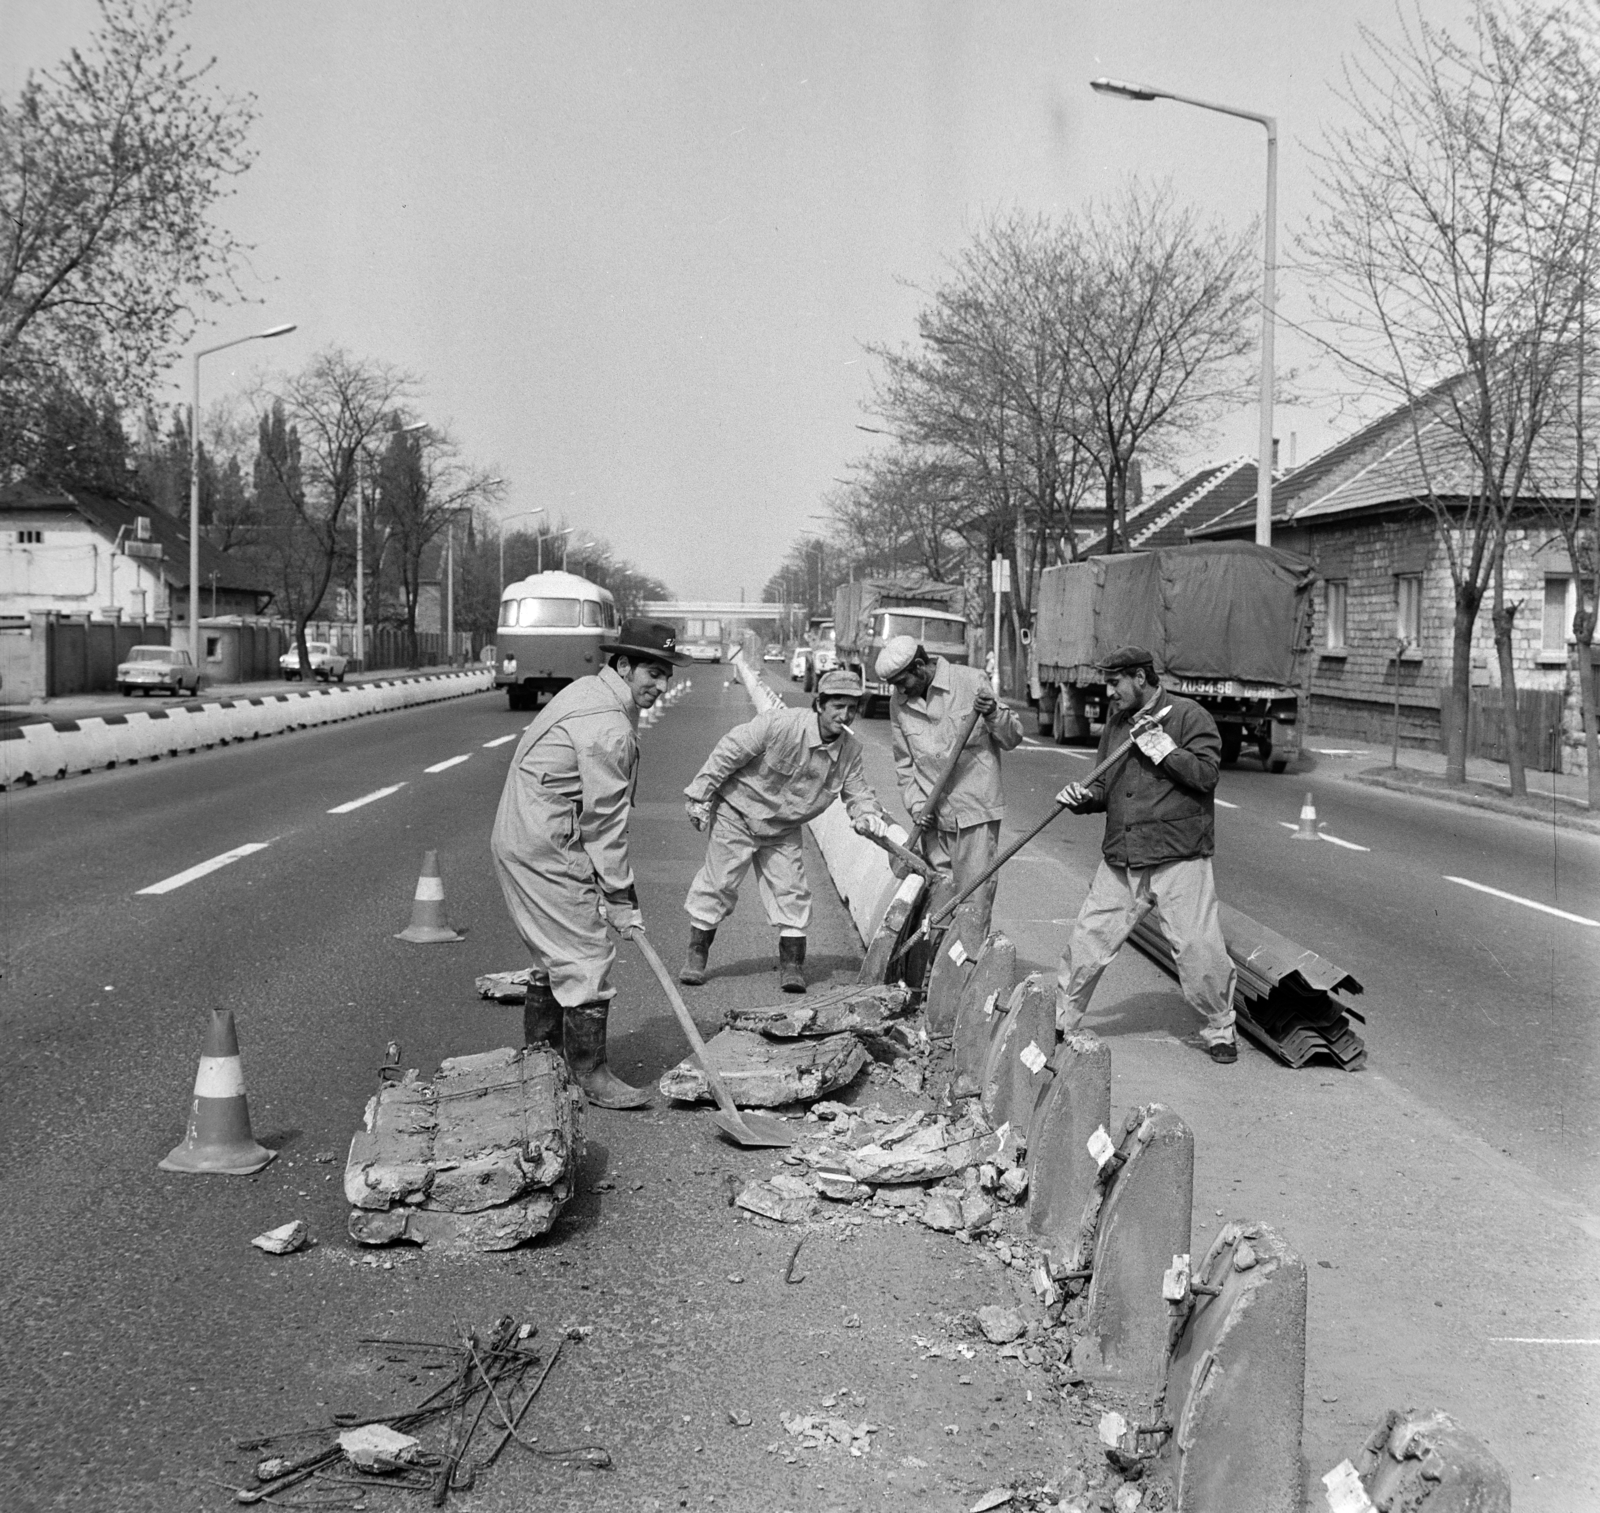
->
[1077,693,1222,867]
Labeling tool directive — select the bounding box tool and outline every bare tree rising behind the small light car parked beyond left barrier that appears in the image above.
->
[256,347,414,677]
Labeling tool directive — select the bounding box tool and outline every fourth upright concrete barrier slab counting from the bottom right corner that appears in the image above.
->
[1027,1023,1110,1263]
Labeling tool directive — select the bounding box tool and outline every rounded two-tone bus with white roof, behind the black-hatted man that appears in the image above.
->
[494,571,618,710]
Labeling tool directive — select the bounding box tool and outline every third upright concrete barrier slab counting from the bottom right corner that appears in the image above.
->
[1072,1104,1196,1394]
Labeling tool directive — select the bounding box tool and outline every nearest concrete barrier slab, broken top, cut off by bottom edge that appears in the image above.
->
[1322,1407,1510,1513]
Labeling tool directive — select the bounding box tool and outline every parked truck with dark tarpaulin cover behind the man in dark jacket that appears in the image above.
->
[1030,541,1317,772]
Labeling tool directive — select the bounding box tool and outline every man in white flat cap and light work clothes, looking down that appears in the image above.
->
[875,635,1022,931]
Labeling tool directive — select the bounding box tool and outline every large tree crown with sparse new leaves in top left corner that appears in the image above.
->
[0,0,254,467]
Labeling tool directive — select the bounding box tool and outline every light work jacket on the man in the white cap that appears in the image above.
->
[890,657,1022,830]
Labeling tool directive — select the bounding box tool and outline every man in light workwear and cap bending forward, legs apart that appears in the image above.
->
[678,670,888,993]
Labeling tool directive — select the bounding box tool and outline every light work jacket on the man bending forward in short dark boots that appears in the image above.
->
[683,709,883,840]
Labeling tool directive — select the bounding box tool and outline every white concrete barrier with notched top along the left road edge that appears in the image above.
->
[0,669,494,790]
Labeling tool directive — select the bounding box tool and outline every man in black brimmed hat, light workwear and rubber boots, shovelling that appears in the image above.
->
[490,621,688,1108]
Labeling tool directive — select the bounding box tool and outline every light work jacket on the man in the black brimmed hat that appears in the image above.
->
[490,667,638,902]
